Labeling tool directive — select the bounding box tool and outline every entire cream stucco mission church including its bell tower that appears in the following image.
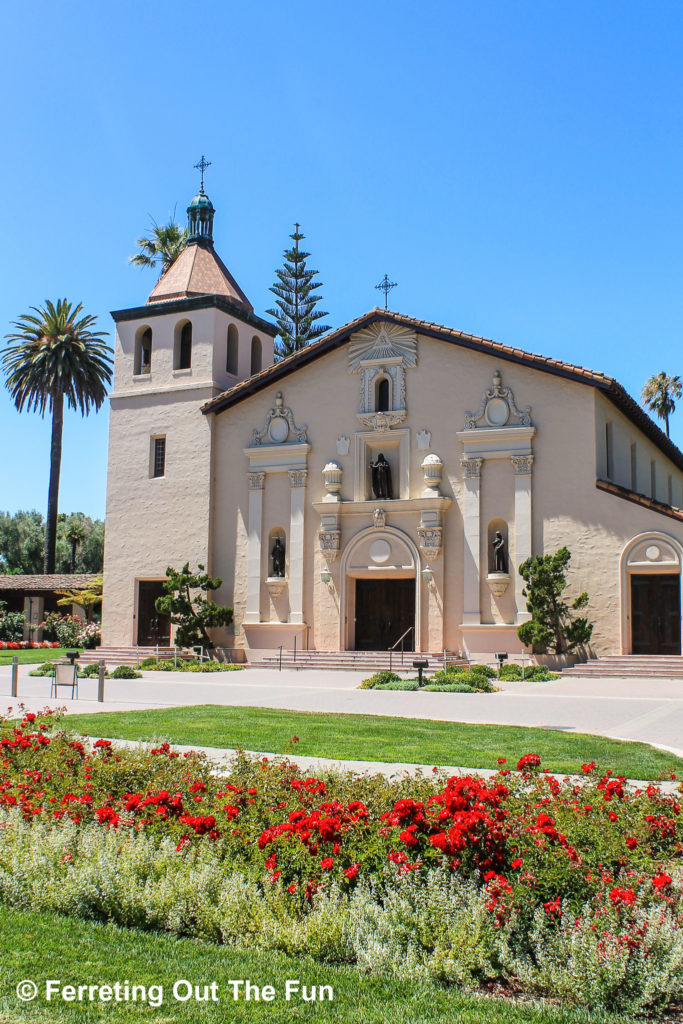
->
[102,190,683,657]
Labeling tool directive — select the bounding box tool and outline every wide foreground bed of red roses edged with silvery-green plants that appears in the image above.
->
[0,715,683,1011]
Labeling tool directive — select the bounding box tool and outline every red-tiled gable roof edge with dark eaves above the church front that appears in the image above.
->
[202,307,683,470]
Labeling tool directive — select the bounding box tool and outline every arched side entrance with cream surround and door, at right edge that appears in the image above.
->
[622,532,683,654]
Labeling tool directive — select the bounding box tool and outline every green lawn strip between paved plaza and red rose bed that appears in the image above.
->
[65,705,683,779]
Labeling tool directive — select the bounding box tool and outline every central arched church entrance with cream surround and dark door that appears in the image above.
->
[340,526,420,650]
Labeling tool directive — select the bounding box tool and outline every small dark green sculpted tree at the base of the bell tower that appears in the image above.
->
[155,562,232,647]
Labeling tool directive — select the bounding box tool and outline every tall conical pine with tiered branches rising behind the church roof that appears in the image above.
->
[266,224,329,359]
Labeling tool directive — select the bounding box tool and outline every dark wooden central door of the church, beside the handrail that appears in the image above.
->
[355,580,415,650]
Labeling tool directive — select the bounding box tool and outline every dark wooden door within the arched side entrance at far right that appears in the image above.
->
[631,574,681,654]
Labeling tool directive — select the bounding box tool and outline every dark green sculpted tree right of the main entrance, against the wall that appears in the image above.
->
[517,548,593,654]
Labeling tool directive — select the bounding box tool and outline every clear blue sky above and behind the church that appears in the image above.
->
[0,0,683,516]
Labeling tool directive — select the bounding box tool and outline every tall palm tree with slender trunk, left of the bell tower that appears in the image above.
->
[2,299,112,572]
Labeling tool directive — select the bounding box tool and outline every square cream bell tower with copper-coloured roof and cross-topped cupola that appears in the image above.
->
[102,165,276,646]
